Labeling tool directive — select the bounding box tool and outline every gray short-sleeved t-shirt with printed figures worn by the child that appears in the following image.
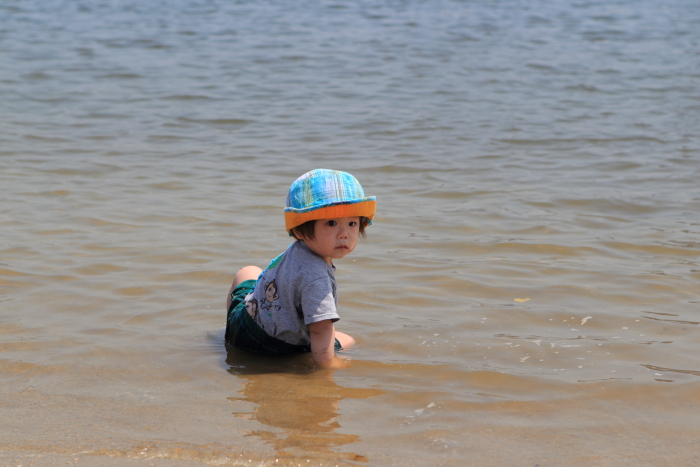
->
[245,241,340,345]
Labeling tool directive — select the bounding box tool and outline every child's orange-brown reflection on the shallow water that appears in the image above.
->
[226,348,382,462]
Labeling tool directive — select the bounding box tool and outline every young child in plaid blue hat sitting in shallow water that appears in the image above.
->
[225,169,377,367]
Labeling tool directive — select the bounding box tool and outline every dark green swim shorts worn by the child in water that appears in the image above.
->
[224,280,343,355]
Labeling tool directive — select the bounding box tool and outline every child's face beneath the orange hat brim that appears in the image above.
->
[303,216,360,264]
